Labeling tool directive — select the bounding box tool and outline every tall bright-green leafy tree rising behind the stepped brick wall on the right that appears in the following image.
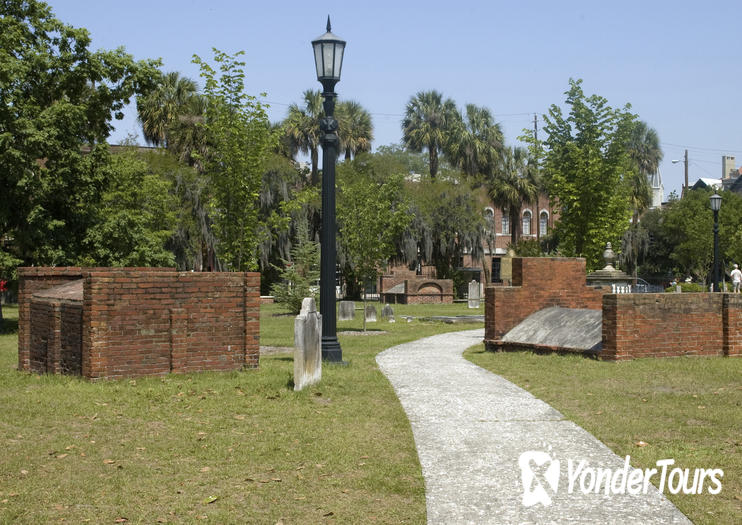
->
[526,79,636,269]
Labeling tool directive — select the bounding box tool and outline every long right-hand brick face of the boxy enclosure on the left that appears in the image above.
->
[82,270,260,378]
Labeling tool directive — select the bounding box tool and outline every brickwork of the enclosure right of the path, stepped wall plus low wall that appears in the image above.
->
[484,257,742,360]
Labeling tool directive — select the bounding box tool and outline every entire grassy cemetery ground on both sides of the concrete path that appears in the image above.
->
[0,303,742,524]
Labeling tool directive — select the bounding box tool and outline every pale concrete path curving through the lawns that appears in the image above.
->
[376,329,690,525]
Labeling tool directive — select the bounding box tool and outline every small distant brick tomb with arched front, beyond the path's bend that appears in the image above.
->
[379,270,453,304]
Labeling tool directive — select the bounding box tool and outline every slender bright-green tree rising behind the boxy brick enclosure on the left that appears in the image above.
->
[193,49,275,271]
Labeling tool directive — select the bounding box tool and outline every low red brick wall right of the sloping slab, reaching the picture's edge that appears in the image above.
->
[600,293,742,360]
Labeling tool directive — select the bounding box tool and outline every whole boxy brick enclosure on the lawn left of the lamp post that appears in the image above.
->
[18,267,260,379]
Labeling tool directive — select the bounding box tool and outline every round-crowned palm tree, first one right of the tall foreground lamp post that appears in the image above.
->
[402,91,458,179]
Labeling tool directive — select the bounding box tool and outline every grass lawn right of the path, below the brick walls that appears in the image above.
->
[465,345,742,524]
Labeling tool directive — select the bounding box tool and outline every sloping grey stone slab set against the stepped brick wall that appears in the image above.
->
[502,306,603,351]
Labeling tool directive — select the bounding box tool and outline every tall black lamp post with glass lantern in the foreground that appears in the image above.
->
[312,16,345,362]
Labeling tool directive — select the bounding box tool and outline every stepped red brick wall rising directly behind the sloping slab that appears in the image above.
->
[484,257,605,341]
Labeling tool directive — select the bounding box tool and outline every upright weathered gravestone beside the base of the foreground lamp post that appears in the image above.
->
[294,297,322,390]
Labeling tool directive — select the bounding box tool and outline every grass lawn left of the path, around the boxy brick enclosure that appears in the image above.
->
[0,303,483,525]
